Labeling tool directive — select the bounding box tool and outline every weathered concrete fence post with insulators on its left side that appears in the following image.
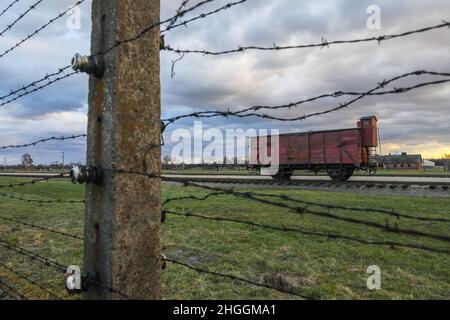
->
[83,0,161,299]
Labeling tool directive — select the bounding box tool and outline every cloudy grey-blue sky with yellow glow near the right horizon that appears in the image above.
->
[0,0,450,164]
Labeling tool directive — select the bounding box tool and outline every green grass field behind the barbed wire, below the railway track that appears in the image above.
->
[0,178,450,299]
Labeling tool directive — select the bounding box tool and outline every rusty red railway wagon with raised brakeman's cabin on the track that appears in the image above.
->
[250,116,378,182]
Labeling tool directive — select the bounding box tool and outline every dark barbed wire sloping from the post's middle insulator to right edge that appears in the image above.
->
[162,177,450,242]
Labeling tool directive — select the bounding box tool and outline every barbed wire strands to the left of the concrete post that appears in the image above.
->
[0,0,90,300]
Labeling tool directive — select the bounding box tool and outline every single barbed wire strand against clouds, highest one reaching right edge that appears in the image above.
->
[163,21,450,56]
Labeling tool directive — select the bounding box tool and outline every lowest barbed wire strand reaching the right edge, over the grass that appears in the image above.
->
[163,209,450,254]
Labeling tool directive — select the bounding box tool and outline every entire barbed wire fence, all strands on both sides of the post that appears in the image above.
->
[0,0,450,299]
